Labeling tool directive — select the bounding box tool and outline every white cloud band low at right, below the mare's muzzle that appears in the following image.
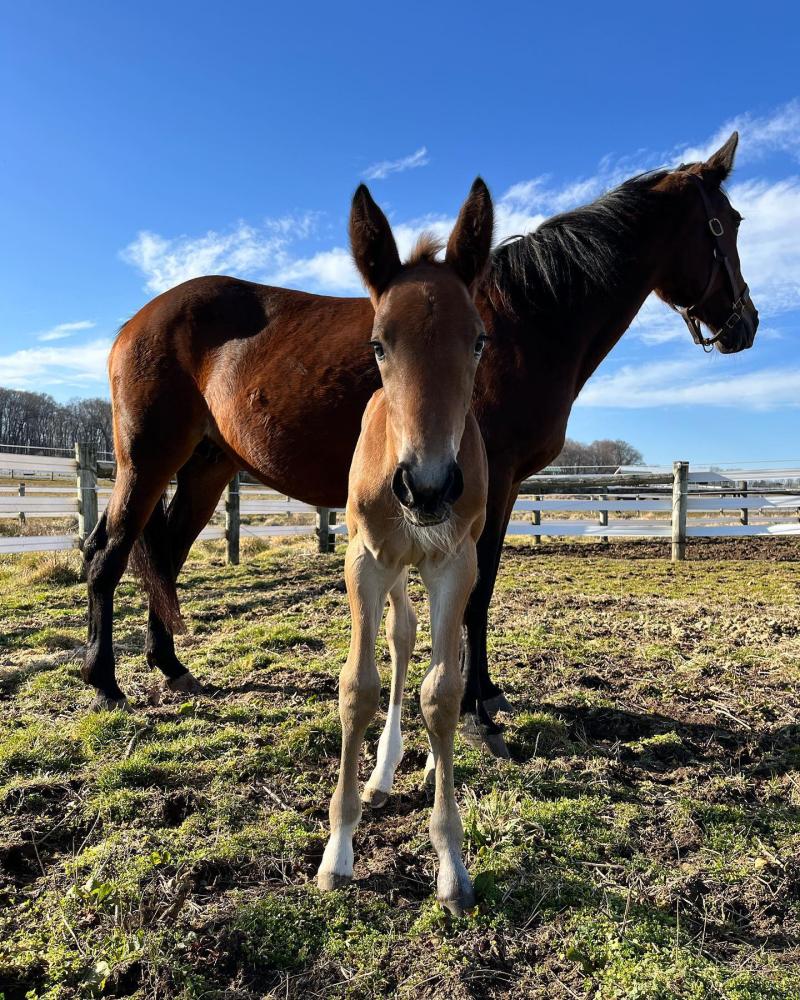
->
[575,358,800,410]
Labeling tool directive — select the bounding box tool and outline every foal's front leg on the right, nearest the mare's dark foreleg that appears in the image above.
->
[420,540,477,916]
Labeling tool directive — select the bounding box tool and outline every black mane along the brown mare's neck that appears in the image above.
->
[485,170,669,311]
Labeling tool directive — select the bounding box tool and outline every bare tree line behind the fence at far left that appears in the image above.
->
[0,388,114,452]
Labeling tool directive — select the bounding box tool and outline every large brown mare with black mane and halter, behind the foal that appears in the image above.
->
[83,133,758,753]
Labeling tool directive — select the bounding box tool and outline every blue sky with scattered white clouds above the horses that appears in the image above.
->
[0,0,800,462]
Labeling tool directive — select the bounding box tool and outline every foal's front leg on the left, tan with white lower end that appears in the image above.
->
[317,535,397,889]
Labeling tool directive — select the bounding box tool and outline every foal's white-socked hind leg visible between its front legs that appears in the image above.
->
[362,570,417,809]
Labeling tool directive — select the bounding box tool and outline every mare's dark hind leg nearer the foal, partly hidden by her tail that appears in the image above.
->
[145,443,236,691]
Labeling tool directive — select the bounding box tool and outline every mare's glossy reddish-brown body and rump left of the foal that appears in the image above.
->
[109,276,377,505]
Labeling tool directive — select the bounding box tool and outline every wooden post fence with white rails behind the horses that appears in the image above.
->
[0,444,800,563]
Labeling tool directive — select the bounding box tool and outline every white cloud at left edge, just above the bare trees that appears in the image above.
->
[0,338,111,392]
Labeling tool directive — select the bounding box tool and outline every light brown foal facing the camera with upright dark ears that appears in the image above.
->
[317,179,493,914]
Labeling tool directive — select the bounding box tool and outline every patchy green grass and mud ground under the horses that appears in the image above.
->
[0,542,800,1000]
